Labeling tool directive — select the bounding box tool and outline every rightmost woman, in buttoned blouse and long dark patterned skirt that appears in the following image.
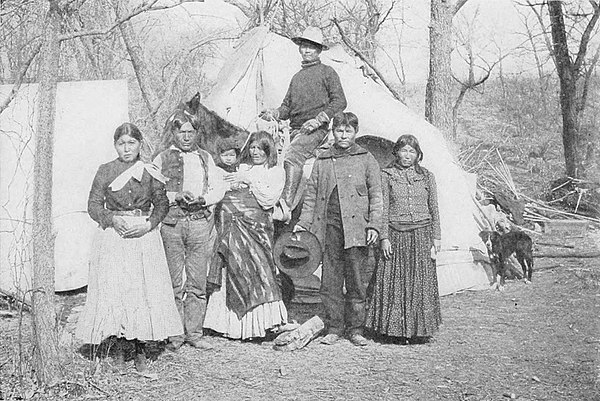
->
[367,135,442,342]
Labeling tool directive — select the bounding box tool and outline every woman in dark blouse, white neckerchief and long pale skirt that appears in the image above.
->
[76,123,183,371]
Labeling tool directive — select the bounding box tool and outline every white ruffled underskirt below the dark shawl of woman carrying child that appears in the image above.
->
[204,269,288,340]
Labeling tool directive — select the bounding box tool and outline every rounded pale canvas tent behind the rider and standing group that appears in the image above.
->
[203,27,489,294]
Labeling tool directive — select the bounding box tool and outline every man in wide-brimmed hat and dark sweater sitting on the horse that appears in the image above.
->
[261,27,346,221]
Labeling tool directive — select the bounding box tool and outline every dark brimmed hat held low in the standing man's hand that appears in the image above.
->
[273,231,322,277]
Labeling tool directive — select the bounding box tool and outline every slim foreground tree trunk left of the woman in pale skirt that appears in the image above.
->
[32,0,62,386]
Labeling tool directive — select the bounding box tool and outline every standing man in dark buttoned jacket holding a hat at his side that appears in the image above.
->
[294,113,383,346]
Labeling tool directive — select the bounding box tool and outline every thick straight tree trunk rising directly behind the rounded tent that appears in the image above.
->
[425,0,454,140]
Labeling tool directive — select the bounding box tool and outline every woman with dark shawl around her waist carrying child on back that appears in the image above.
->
[204,131,287,339]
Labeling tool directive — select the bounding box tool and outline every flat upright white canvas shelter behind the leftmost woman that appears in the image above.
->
[0,80,129,297]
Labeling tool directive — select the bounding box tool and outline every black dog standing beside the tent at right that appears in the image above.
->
[479,231,533,290]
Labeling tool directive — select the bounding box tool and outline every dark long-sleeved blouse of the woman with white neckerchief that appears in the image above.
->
[88,159,169,229]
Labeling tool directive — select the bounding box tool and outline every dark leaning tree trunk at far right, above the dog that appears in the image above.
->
[548,1,585,178]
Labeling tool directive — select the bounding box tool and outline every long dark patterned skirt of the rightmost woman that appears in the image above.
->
[366,226,442,338]
